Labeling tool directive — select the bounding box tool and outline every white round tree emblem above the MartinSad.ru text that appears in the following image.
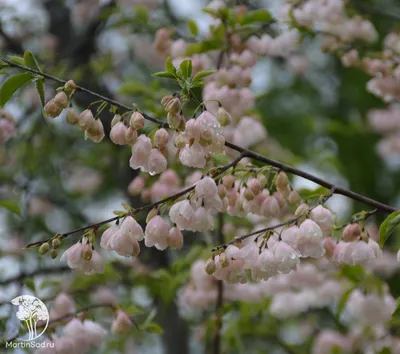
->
[11,295,49,341]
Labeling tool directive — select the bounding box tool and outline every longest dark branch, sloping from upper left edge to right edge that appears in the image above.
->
[2,59,398,221]
